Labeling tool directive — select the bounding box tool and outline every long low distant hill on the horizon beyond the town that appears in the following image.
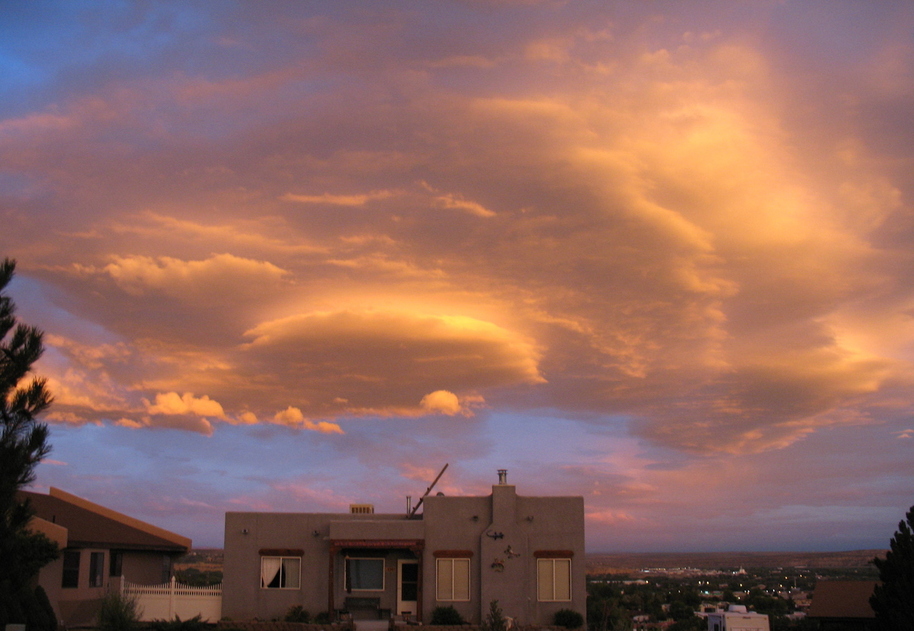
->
[586,550,885,574]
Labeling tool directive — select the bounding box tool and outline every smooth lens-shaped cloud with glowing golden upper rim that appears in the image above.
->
[242,309,544,416]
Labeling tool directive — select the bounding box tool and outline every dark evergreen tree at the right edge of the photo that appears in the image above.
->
[870,506,914,631]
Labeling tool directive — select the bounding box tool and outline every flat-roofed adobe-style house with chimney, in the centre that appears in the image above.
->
[222,470,587,624]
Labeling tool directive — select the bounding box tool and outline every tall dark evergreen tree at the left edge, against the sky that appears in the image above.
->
[0,259,57,592]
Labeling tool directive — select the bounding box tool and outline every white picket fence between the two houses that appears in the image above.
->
[121,577,222,622]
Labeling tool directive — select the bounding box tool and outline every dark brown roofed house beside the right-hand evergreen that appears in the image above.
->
[807,581,878,631]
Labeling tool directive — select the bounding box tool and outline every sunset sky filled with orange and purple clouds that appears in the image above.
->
[0,0,914,552]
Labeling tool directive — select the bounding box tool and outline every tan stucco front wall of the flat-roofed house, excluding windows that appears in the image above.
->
[223,484,587,624]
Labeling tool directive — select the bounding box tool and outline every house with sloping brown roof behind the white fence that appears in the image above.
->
[20,487,191,626]
